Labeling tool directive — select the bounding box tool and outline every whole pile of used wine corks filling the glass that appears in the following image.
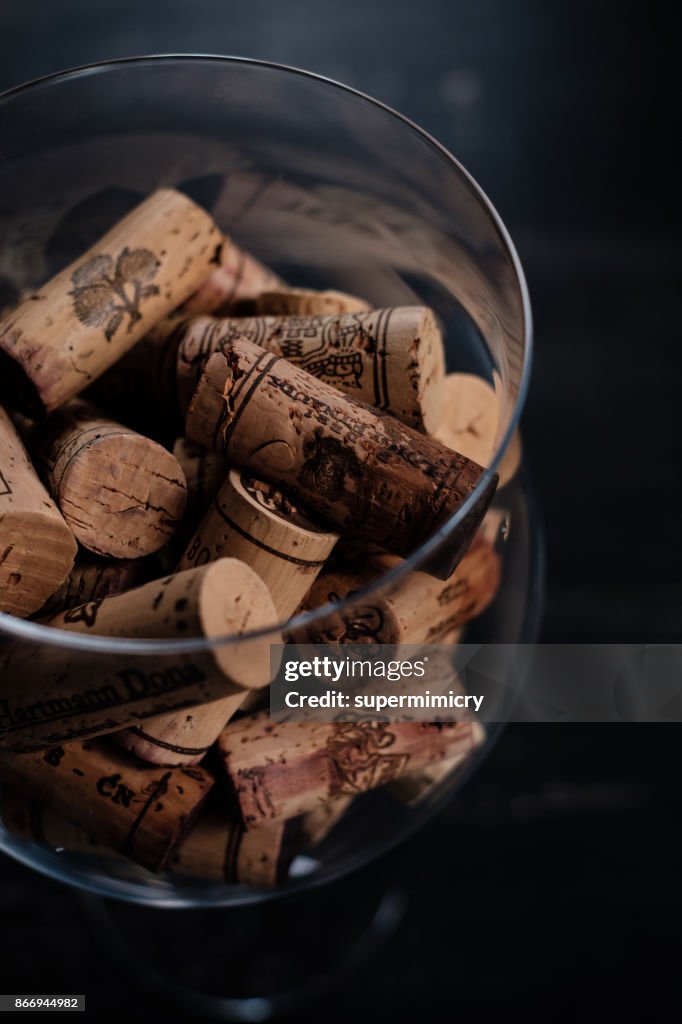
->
[0,189,519,886]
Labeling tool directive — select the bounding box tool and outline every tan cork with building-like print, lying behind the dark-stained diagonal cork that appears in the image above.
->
[177,306,444,433]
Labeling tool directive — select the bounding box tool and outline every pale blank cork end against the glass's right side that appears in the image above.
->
[433,374,521,489]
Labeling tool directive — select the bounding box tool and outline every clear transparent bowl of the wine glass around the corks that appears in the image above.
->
[0,56,538,906]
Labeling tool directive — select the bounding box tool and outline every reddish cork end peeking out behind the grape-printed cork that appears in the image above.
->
[181,241,286,315]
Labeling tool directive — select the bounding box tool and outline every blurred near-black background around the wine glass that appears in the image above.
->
[0,0,682,1021]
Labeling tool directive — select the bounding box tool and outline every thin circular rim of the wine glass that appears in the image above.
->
[0,53,532,655]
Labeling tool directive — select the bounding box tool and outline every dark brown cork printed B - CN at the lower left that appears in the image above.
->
[0,741,213,871]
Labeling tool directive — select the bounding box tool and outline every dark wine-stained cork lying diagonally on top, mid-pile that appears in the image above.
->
[186,341,497,578]
